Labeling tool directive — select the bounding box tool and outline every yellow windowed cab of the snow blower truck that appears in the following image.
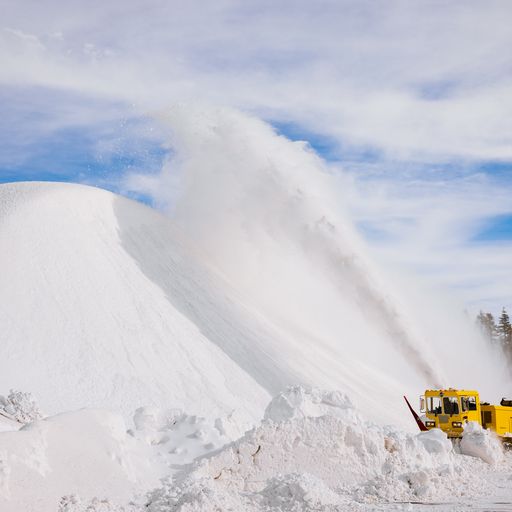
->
[420,388,482,438]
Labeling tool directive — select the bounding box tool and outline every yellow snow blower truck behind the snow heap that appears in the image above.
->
[404,388,512,443]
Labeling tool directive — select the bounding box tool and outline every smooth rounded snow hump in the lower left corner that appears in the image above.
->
[0,410,162,512]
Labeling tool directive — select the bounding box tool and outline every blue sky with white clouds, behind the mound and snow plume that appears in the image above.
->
[0,0,512,308]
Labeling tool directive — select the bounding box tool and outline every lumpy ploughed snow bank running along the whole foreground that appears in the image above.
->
[0,386,508,512]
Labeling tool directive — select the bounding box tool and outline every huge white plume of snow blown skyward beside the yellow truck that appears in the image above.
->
[129,105,508,413]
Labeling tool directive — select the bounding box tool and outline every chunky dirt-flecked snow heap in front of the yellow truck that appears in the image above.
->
[145,387,496,512]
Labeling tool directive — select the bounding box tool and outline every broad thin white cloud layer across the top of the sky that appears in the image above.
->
[0,1,512,158]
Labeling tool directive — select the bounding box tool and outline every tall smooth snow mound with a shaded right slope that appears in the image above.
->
[0,183,280,417]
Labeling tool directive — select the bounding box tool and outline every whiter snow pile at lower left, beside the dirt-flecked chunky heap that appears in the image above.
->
[0,395,244,512]
